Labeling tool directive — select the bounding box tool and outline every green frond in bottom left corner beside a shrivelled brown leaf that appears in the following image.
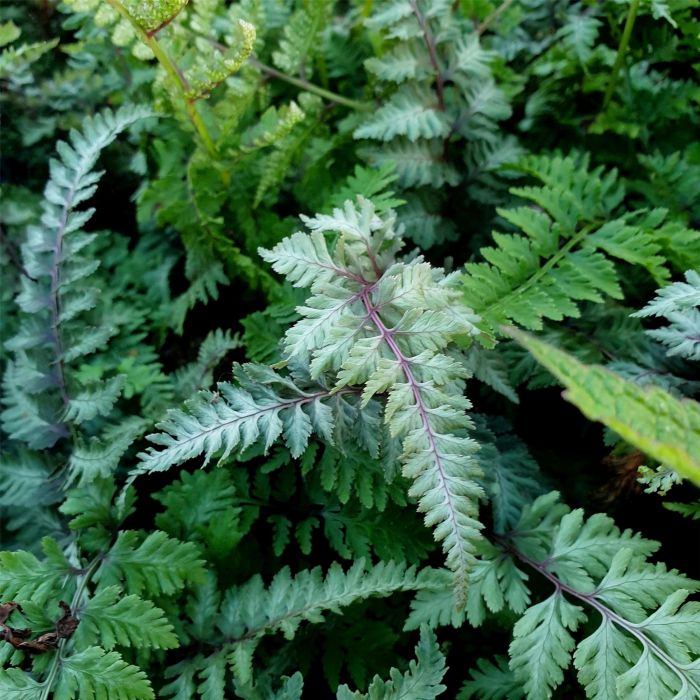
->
[0,528,201,700]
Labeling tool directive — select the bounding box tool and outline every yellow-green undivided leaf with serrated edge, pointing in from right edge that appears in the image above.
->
[509,330,700,484]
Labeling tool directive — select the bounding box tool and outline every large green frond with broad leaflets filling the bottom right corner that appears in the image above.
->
[462,493,700,700]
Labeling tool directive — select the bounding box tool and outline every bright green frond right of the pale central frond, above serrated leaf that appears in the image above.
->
[463,157,669,340]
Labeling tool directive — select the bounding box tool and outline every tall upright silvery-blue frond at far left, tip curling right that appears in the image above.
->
[3,107,149,448]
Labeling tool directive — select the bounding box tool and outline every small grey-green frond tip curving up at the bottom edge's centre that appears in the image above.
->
[336,626,447,700]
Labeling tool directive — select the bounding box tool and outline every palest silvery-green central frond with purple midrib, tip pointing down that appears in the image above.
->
[261,198,482,604]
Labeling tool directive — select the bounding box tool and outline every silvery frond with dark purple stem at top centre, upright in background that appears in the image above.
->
[353,0,511,247]
